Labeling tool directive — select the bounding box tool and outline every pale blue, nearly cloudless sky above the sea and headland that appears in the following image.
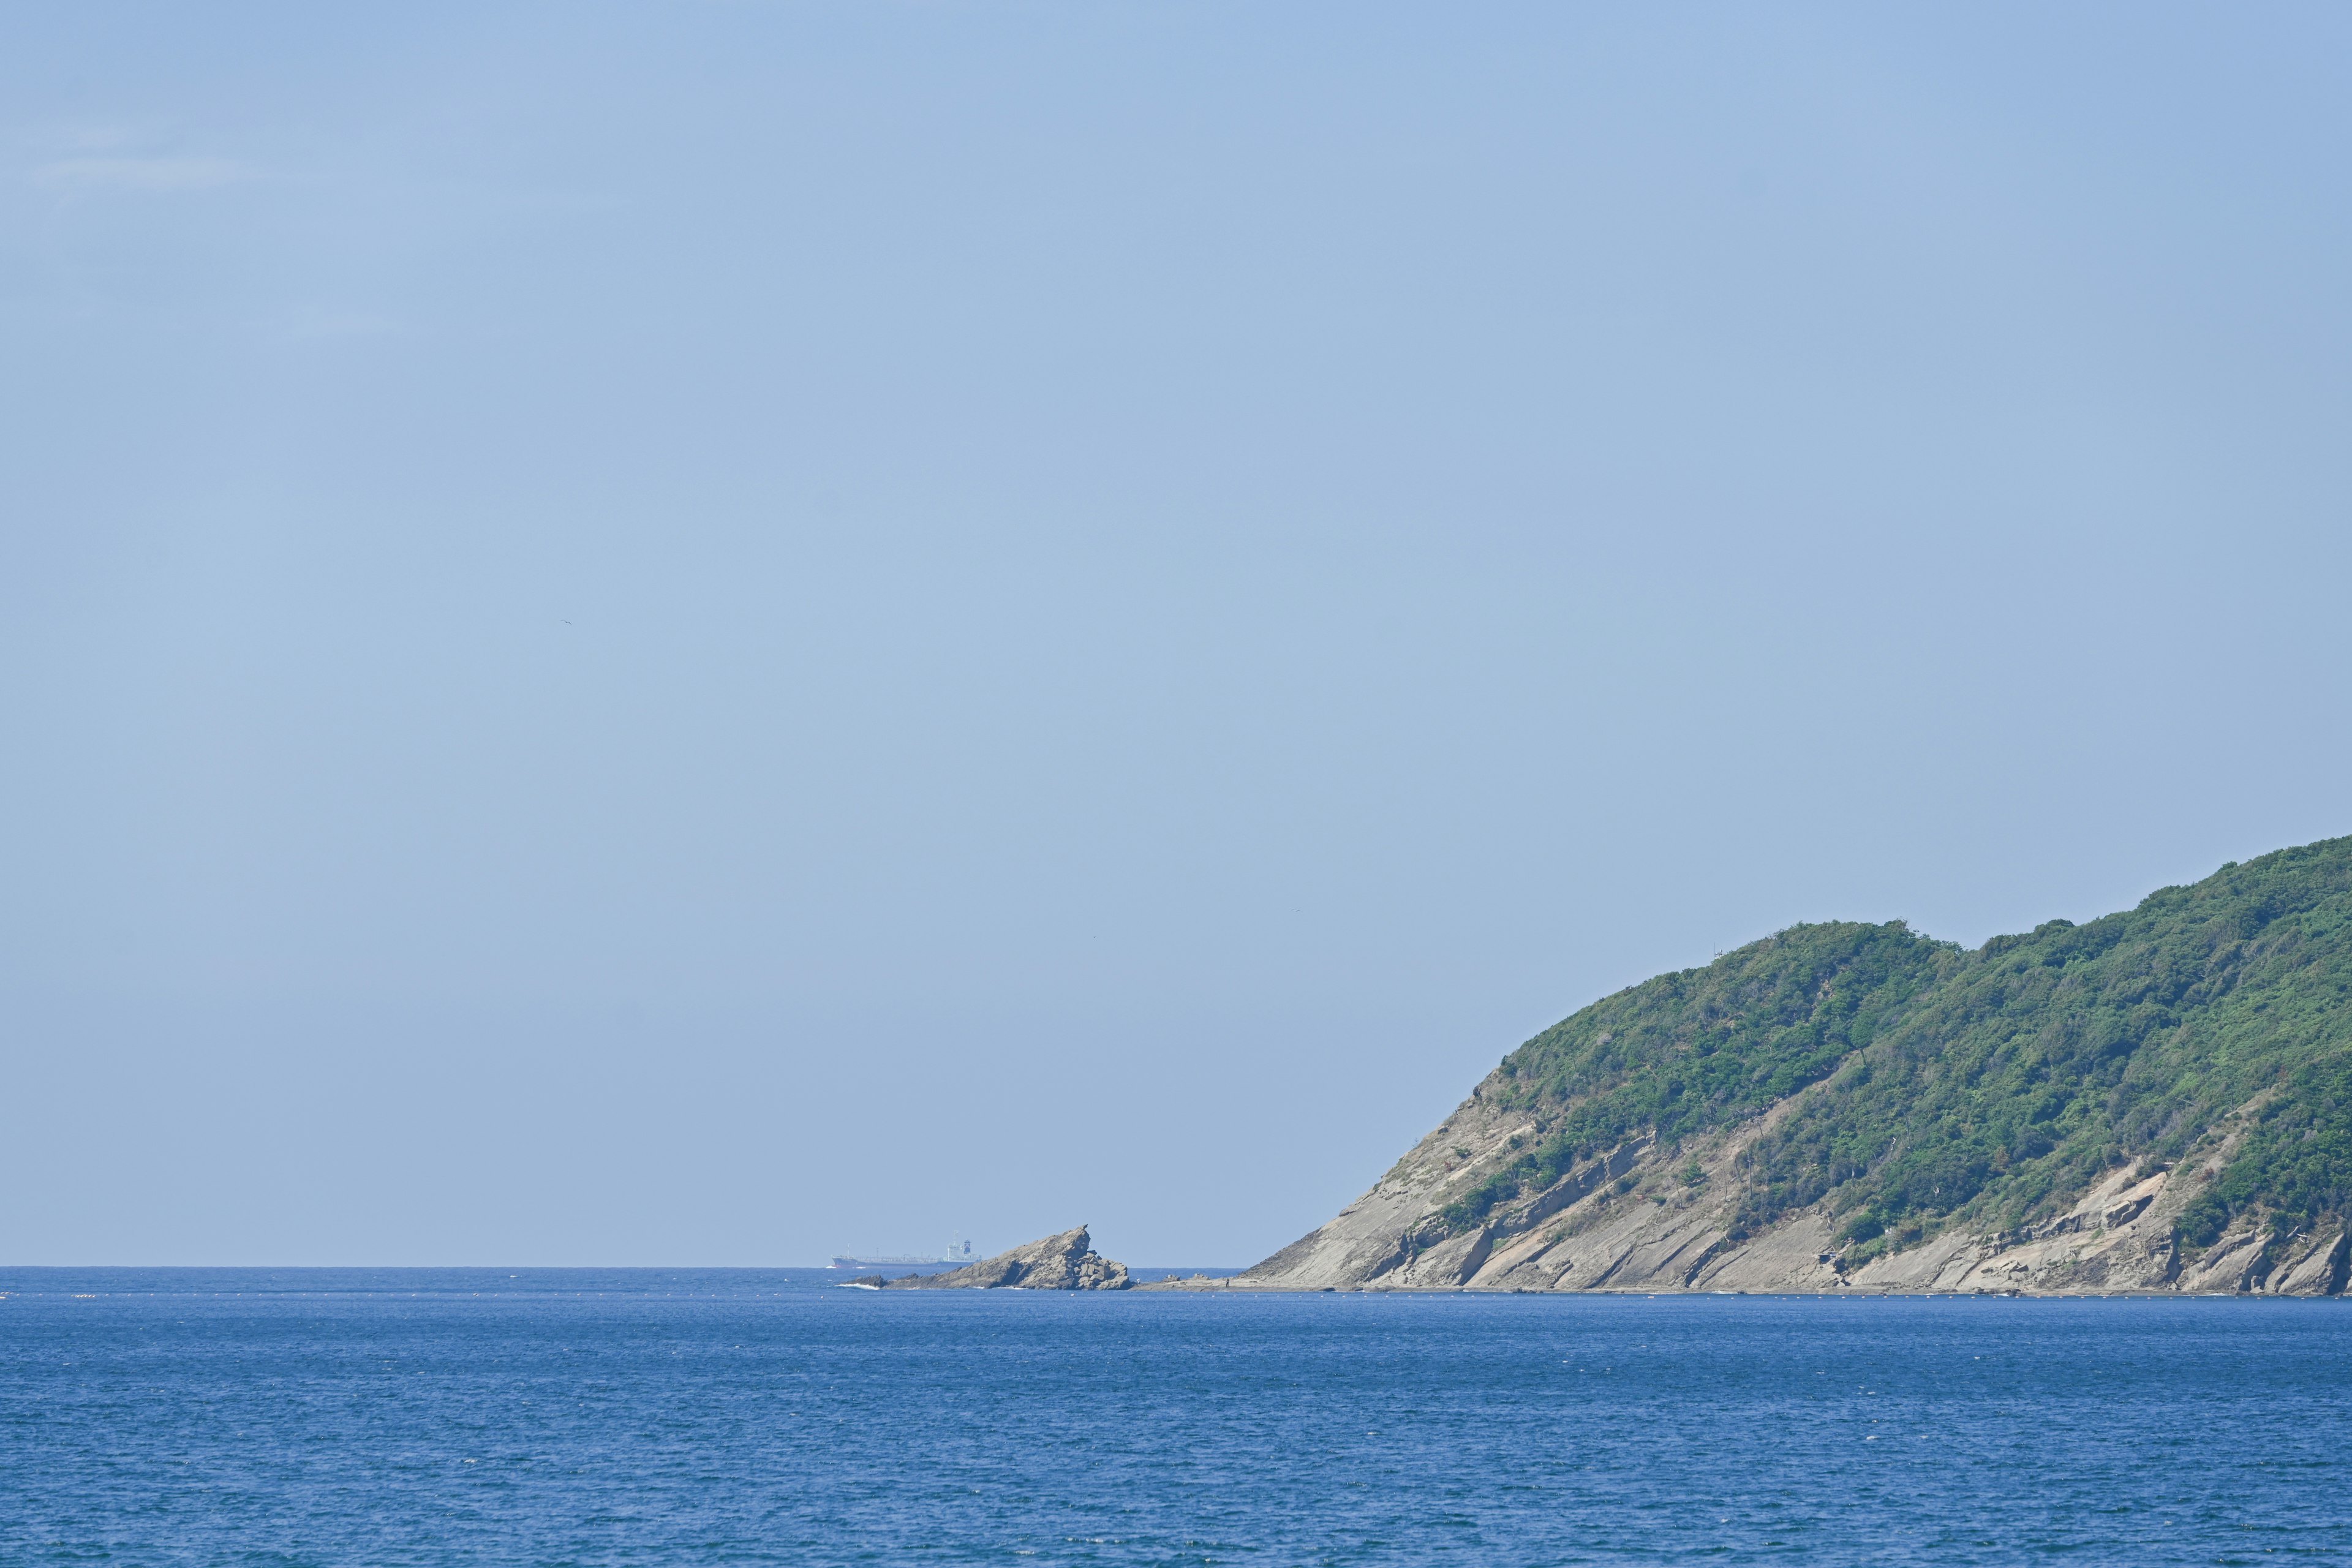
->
[0,0,2352,1265]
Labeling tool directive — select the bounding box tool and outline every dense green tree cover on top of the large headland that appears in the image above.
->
[1442,839,2352,1256]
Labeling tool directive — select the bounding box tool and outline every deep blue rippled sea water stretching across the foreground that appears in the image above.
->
[0,1270,2352,1566]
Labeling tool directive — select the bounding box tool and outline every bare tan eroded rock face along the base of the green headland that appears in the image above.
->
[1145,1082,2347,1295]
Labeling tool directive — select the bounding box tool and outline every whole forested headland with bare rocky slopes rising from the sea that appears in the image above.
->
[1178,839,2352,1295]
